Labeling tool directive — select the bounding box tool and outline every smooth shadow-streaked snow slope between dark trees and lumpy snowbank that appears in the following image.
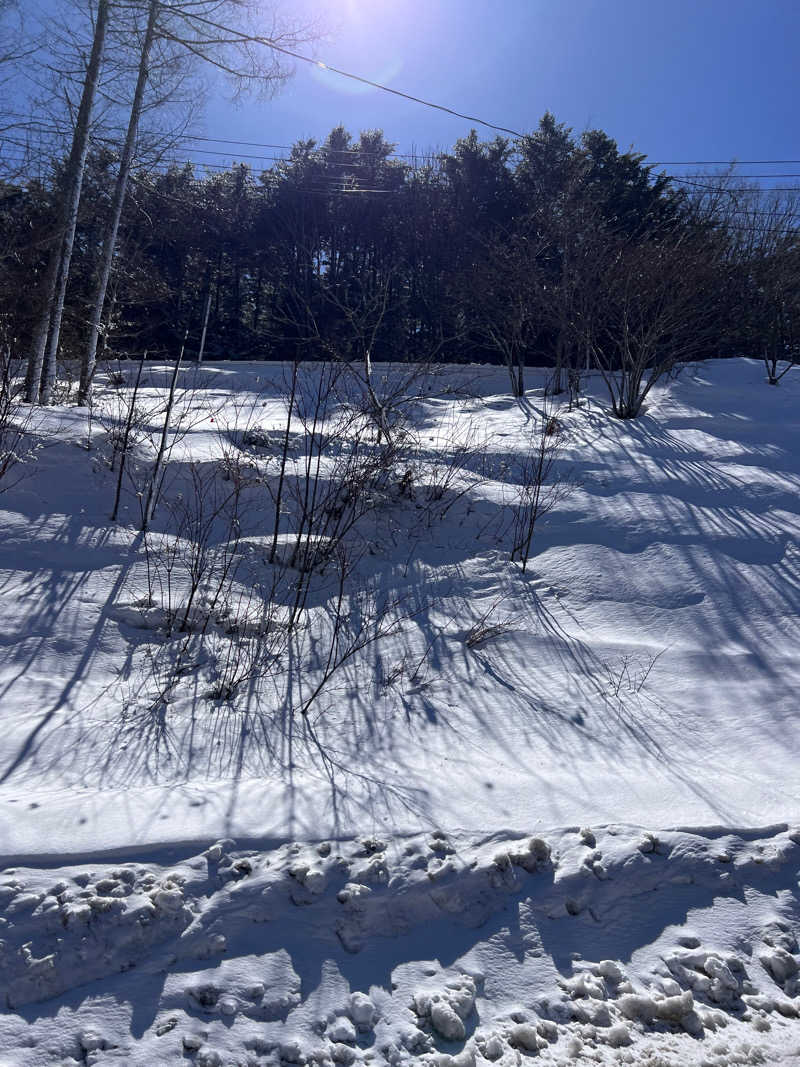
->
[0,361,800,857]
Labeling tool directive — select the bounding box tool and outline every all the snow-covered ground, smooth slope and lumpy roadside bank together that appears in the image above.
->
[0,361,800,1067]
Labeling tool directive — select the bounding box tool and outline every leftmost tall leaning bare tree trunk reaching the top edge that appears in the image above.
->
[26,0,109,403]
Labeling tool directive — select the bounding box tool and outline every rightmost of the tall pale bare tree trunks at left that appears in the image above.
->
[78,0,159,403]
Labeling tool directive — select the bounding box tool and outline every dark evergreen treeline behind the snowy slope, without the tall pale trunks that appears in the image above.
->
[0,114,800,403]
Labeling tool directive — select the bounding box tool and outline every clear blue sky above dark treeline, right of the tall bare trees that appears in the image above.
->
[194,0,800,179]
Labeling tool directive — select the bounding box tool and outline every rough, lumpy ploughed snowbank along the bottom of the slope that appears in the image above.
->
[0,826,800,1067]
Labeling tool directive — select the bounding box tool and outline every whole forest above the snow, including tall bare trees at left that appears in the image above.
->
[0,0,800,417]
